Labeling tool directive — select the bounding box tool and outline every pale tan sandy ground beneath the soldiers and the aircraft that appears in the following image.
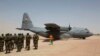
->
[0,36,100,56]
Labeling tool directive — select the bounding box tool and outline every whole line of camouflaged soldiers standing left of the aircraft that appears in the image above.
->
[0,33,39,54]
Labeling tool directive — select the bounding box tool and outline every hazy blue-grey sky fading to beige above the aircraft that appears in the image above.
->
[0,0,100,33]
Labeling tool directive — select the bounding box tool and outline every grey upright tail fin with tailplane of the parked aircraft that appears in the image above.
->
[17,13,33,30]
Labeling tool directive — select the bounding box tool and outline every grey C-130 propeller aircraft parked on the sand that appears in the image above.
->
[16,13,93,40]
